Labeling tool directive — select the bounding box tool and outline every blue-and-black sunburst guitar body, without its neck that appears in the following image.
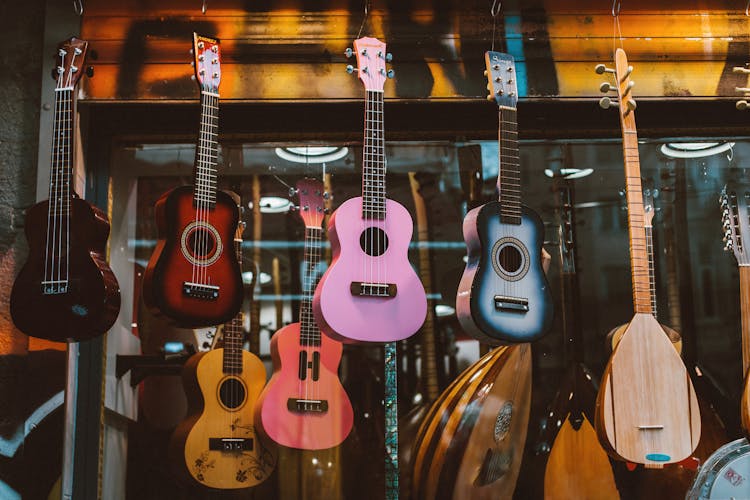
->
[456,202,553,344]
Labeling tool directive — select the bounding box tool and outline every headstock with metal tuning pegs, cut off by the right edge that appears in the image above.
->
[719,186,750,266]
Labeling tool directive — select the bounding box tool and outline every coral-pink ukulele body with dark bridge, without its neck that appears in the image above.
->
[255,323,354,450]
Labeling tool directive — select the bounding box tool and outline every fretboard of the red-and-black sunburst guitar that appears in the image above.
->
[193,90,219,207]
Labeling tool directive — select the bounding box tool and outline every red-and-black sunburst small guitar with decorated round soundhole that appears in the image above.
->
[143,33,243,327]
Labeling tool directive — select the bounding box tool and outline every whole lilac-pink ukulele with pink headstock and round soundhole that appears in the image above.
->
[313,38,427,342]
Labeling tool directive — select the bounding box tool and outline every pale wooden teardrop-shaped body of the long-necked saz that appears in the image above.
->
[595,313,701,465]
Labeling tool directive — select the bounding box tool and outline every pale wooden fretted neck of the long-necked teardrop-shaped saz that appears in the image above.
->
[622,132,653,313]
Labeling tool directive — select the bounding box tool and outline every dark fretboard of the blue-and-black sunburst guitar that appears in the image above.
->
[497,106,521,224]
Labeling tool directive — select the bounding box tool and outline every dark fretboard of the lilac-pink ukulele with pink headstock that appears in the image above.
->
[362,90,385,220]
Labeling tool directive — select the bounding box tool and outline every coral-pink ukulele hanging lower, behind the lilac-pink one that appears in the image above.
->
[255,179,354,450]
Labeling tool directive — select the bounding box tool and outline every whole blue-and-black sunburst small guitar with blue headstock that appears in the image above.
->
[456,52,553,345]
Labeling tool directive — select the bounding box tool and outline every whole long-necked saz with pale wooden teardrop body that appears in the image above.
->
[596,49,700,467]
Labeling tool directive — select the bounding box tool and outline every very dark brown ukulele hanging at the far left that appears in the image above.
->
[10,38,120,342]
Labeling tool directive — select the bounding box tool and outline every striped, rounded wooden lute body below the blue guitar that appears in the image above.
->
[412,344,531,500]
